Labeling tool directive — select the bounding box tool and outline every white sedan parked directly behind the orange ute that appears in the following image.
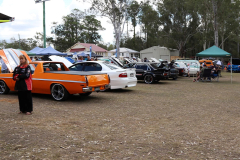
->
[69,61,137,89]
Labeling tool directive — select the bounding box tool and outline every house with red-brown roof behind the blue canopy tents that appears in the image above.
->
[66,42,108,57]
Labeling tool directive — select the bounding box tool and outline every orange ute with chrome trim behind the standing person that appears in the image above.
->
[0,61,110,101]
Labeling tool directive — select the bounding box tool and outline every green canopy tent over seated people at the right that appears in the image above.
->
[196,46,232,83]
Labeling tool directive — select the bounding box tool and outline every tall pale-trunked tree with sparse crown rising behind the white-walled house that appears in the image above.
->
[89,0,131,57]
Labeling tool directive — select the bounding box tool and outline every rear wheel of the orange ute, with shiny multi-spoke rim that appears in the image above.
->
[51,84,69,101]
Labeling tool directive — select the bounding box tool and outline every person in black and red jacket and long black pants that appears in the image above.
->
[13,55,33,115]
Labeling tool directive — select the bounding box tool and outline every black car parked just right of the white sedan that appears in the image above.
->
[124,62,168,84]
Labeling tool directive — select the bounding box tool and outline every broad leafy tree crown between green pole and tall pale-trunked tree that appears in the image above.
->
[50,9,104,52]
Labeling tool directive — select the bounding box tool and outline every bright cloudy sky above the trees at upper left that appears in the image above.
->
[0,0,114,44]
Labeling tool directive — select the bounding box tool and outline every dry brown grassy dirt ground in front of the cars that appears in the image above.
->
[0,72,240,160]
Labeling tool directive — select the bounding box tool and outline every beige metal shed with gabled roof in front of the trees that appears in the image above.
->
[140,46,179,61]
